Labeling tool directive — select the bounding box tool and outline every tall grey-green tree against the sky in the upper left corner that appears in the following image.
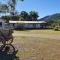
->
[0,0,24,15]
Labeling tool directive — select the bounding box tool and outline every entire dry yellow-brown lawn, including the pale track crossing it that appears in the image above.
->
[13,30,60,60]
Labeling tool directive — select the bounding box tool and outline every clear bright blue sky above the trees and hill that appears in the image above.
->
[0,0,60,18]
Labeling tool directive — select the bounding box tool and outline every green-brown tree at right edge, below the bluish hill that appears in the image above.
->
[47,19,60,30]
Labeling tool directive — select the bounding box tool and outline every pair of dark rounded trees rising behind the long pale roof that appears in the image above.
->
[20,11,38,21]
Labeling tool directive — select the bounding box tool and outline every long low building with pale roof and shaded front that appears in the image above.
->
[9,21,47,29]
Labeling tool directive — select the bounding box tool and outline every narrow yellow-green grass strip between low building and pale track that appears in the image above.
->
[14,30,60,35]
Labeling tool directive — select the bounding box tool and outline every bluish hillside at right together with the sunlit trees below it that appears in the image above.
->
[40,13,60,30]
